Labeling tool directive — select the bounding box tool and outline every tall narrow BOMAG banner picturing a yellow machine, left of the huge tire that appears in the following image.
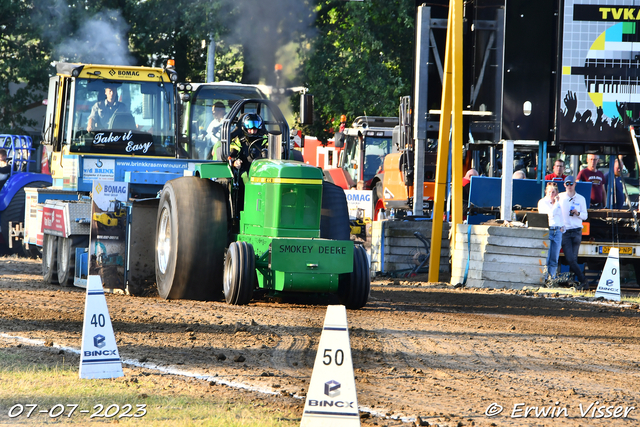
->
[89,180,129,290]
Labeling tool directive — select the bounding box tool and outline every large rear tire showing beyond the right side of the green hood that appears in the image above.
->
[320,181,351,240]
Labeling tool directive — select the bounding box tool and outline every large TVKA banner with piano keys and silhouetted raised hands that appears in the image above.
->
[557,0,640,144]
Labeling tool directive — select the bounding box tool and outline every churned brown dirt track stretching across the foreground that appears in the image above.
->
[0,257,640,426]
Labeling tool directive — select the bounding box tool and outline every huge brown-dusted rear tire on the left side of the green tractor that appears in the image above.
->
[155,177,228,300]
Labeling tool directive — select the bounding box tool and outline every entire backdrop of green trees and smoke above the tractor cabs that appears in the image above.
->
[0,0,415,139]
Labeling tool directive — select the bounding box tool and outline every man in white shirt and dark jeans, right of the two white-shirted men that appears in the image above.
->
[560,175,589,290]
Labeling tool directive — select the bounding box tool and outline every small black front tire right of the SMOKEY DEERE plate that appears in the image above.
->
[338,245,371,309]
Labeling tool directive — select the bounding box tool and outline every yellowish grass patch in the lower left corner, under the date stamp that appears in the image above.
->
[0,346,300,427]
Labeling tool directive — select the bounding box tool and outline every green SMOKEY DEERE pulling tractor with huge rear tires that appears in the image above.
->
[156,99,370,309]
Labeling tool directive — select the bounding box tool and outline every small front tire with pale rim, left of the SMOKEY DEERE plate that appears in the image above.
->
[224,242,256,305]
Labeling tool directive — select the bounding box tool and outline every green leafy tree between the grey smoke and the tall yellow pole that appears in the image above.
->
[293,0,415,141]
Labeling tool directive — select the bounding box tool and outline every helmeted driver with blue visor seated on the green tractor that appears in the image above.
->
[229,113,268,179]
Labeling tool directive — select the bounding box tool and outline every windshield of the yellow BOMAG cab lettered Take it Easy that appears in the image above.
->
[66,79,176,157]
